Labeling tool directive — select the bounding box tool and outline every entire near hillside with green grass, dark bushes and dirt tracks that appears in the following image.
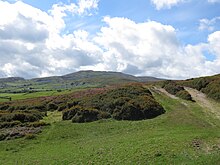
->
[0,72,220,165]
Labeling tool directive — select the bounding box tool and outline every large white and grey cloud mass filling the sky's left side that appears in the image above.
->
[0,0,101,78]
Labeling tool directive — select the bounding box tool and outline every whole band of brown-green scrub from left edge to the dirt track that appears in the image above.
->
[0,84,165,123]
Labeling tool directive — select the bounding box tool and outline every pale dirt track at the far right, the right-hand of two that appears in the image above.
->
[185,87,220,119]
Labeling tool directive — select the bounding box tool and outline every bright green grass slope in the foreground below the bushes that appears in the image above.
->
[0,88,220,165]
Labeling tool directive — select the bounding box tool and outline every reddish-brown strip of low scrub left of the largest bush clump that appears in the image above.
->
[0,87,108,116]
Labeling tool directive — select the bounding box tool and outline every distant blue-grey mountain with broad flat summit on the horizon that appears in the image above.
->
[0,70,162,93]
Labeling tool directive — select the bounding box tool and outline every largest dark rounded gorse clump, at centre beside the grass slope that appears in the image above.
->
[63,85,165,123]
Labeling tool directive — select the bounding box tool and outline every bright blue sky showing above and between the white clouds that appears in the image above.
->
[19,0,220,44]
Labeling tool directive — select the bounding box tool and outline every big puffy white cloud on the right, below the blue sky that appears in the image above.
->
[92,17,219,78]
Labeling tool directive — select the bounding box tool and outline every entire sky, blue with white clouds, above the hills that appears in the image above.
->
[0,0,220,79]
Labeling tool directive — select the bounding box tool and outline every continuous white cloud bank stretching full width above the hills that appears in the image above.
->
[0,0,220,79]
